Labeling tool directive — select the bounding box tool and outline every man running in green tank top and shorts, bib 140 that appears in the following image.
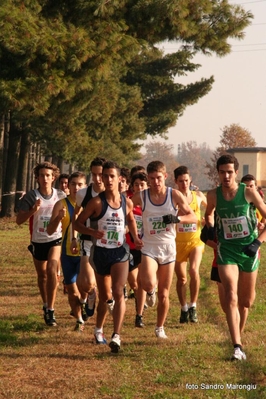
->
[205,154,266,360]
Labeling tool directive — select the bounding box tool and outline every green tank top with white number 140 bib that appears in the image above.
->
[215,183,258,245]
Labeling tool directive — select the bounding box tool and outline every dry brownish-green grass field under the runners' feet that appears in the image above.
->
[0,219,266,399]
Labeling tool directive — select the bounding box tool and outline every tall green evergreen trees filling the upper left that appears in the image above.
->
[0,0,252,216]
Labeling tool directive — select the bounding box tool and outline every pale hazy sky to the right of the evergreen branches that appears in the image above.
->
[144,0,266,152]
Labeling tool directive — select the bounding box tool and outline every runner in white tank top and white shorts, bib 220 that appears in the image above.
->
[132,161,197,338]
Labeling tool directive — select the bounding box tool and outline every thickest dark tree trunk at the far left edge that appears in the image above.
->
[0,123,21,217]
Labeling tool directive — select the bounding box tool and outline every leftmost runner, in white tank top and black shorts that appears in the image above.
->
[16,162,65,326]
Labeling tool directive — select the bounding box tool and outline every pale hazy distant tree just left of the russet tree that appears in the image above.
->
[177,141,212,190]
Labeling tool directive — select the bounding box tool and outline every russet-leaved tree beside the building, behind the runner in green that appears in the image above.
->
[206,123,257,186]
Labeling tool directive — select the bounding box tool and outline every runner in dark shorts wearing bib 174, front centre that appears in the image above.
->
[75,161,142,353]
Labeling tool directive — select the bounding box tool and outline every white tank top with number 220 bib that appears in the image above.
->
[140,187,177,246]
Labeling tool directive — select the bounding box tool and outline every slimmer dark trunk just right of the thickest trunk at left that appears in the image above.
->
[15,133,30,212]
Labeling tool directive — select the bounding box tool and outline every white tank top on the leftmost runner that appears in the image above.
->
[31,188,65,243]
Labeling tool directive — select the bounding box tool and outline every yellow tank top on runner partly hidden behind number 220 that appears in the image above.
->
[176,191,201,243]
